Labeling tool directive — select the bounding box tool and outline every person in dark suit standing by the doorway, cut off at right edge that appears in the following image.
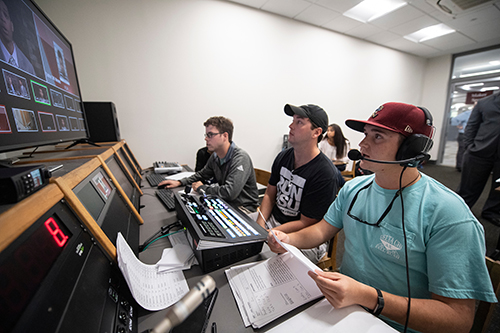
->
[458,93,500,227]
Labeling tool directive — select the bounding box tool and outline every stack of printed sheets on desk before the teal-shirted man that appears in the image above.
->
[226,235,322,328]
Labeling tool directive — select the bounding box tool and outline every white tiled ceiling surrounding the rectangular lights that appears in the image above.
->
[227,0,500,57]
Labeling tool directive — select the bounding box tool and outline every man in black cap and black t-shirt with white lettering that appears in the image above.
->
[257,104,341,263]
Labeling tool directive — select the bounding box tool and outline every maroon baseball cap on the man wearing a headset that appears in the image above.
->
[345,102,434,138]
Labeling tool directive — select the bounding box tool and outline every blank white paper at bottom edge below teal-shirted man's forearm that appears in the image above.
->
[267,299,397,333]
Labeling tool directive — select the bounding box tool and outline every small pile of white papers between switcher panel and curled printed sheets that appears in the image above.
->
[156,230,198,272]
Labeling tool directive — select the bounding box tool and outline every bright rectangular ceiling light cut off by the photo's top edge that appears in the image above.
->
[342,0,406,23]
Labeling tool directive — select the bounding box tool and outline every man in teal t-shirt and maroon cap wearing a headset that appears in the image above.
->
[268,103,498,332]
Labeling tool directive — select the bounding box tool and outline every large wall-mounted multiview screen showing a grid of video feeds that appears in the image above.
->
[0,0,88,152]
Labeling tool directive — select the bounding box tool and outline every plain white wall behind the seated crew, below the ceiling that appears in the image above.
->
[37,0,449,170]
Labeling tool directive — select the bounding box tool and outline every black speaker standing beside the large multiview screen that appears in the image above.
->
[83,102,121,142]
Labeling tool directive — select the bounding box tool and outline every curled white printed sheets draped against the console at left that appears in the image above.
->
[116,232,189,311]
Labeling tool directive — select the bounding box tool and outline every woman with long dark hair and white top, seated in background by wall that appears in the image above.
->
[318,124,350,171]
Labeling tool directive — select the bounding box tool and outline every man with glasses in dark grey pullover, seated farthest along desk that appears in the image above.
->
[158,116,259,212]
